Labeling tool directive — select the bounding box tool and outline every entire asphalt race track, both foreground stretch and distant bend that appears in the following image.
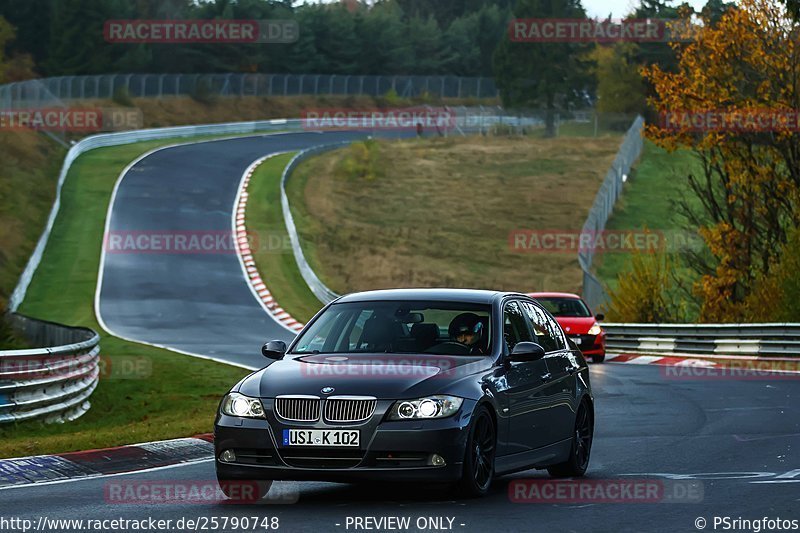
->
[75,133,800,532]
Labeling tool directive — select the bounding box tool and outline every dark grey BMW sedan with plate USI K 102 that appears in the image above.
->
[214,289,594,496]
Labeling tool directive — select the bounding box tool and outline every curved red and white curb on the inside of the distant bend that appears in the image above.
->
[234,153,303,333]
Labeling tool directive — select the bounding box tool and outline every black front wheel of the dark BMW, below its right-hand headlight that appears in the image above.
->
[458,407,497,498]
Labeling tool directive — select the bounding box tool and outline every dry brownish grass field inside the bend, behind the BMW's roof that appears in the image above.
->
[288,135,622,293]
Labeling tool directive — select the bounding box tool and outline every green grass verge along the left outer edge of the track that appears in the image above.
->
[0,133,255,457]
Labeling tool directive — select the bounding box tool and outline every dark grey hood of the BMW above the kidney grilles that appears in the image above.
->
[234,354,492,399]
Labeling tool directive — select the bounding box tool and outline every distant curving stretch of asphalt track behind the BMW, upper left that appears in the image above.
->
[98,132,366,368]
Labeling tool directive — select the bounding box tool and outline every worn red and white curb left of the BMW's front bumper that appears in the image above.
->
[0,434,214,490]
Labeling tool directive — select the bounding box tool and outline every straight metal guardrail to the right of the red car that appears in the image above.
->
[603,324,800,357]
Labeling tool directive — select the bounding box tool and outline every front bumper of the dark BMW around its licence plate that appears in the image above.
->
[214,400,475,482]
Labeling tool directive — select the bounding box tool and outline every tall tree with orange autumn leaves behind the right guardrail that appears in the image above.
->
[642,0,800,321]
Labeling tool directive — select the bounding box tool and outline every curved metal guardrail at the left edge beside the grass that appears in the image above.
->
[0,314,100,423]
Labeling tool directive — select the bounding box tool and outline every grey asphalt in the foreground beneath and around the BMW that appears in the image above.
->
[0,364,800,532]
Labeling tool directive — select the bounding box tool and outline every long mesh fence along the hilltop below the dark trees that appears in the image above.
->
[0,74,498,109]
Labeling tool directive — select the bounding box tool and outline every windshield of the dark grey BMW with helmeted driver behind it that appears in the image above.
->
[292,301,491,355]
